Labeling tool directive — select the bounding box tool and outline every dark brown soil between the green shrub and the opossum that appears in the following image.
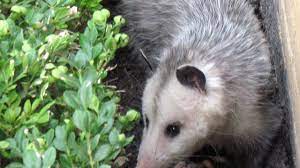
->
[108,48,148,168]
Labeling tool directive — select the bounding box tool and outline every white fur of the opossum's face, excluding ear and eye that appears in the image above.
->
[139,64,226,167]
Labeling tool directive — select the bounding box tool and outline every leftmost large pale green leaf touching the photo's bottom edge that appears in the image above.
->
[23,149,42,168]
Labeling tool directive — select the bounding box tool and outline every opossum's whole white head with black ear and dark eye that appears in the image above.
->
[137,62,226,168]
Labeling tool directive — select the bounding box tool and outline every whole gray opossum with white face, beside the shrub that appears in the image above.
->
[116,0,281,168]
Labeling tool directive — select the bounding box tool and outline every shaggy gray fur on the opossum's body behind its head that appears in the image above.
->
[116,0,281,168]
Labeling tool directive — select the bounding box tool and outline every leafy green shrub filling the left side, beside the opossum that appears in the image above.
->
[0,0,140,168]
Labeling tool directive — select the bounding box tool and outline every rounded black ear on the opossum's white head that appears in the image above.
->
[176,65,206,92]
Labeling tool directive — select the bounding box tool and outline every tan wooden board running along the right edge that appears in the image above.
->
[279,0,300,167]
